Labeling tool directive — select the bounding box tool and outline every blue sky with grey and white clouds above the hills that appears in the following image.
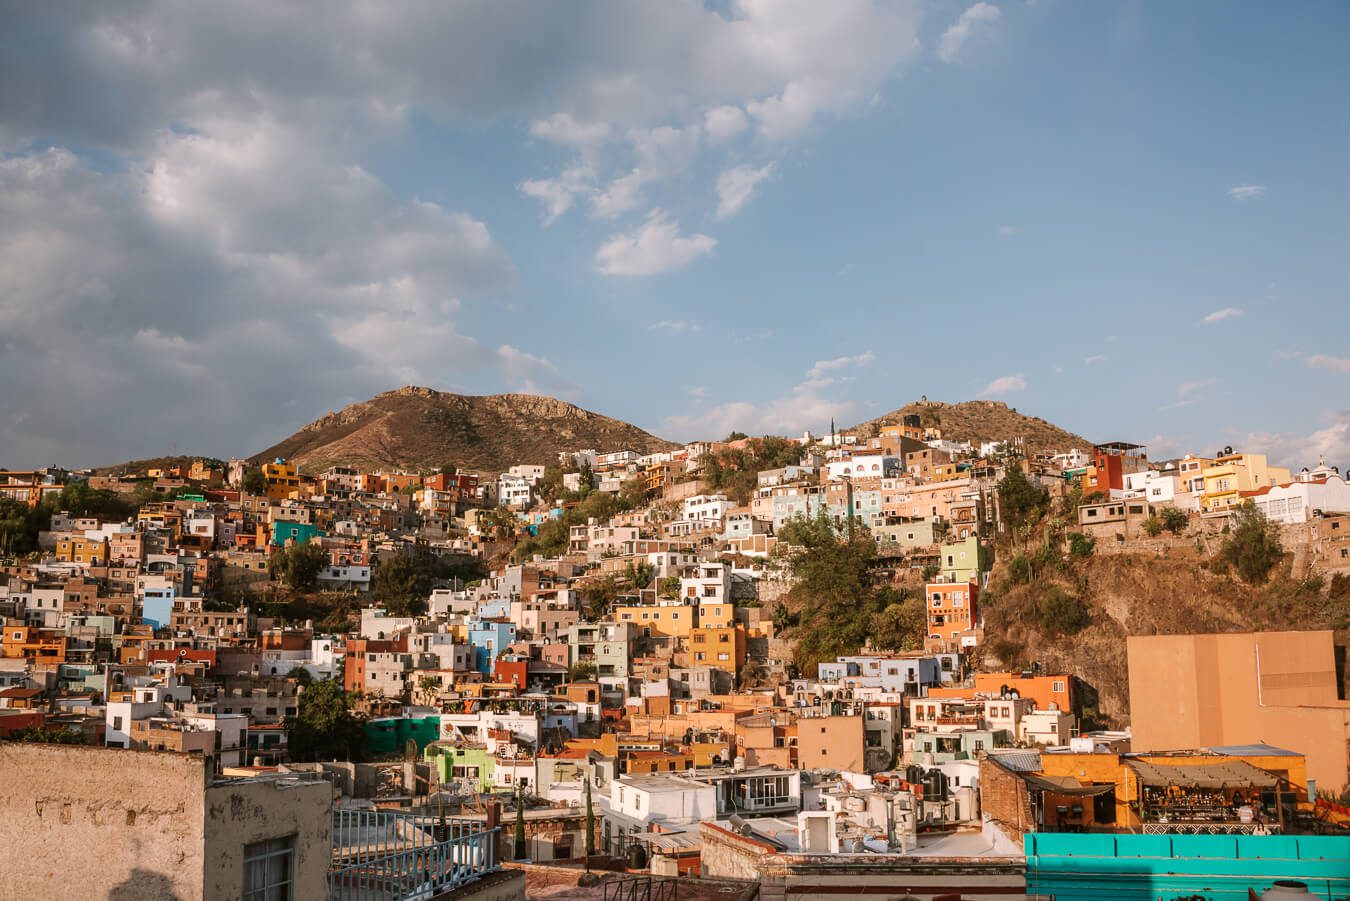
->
[0,0,1350,469]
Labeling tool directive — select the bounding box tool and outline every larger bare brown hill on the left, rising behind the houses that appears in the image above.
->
[252,386,675,473]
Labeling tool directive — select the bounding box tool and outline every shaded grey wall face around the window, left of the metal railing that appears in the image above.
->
[203,781,333,901]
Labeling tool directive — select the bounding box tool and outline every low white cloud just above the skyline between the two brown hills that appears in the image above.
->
[662,351,873,439]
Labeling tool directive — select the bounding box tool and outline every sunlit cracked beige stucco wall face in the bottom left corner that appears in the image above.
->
[0,743,207,901]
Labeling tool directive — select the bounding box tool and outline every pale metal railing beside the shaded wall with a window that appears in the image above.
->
[328,809,498,901]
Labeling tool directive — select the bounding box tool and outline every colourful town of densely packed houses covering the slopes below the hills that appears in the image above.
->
[0,401,1350,898]
